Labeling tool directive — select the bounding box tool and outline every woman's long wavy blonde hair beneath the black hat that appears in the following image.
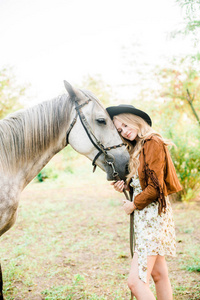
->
[113,113,174,183]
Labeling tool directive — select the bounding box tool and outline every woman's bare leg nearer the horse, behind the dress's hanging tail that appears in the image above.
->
[128,253,157,300]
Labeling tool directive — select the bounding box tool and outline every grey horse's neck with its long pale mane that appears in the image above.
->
[1,98,71,189]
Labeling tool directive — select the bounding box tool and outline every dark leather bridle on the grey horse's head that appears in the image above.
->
[66,97,125,177]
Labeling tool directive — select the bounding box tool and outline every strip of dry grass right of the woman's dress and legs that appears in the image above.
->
[171,202,200,300]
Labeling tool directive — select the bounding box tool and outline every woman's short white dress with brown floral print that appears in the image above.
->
[131,176,176,282]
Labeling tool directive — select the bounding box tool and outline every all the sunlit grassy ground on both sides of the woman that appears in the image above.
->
[0,154,200,300]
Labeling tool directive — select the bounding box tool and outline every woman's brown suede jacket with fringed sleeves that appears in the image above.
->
[134,136,182,213]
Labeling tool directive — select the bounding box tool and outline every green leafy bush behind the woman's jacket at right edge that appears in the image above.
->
[154,103,200,200]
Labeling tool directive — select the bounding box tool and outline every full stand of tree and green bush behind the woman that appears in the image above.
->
[149,58,200,200]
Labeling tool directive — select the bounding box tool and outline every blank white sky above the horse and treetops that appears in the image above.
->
[0,0,192,105]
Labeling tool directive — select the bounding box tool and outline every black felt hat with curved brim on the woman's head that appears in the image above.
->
[106,104,152,126]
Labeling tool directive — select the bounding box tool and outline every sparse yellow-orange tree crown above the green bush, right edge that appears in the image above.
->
[157,57,200,126]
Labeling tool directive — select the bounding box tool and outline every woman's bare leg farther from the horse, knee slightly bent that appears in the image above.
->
[151,255,173,300]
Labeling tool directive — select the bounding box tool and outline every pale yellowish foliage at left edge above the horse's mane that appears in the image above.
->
[0,68,26,118]
